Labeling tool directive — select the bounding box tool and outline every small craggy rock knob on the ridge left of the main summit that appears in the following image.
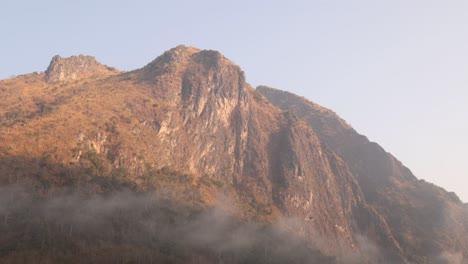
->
[45,55,116,83]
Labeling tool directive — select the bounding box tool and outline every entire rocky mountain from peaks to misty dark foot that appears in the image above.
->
[0,46,468,263]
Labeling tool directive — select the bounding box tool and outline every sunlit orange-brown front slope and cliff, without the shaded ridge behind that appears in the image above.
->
[0,46,380,260]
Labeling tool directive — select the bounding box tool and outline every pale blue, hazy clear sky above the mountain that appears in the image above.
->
[0,0,468,202]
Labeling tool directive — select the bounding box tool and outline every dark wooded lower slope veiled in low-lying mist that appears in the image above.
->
[0,185,336,263]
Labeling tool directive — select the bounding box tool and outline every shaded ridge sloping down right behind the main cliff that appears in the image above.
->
[257,86,468,263]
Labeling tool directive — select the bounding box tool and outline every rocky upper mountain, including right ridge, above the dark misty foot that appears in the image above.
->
[0,46,467,263]
